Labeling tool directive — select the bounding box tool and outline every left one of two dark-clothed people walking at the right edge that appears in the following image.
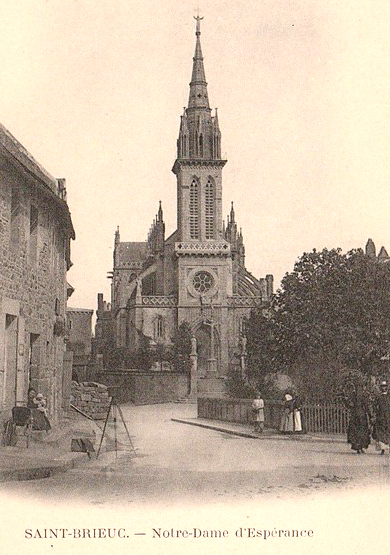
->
[347,386,370,454]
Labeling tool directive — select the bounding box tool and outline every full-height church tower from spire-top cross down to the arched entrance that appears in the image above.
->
[172,16,233,376]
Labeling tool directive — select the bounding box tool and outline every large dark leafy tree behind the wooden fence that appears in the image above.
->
[247,249,390,400]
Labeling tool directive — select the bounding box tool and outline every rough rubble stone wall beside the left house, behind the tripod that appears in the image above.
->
[70,382,110,420]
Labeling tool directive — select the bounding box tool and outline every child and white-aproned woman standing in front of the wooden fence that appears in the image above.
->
[252,391,303,434]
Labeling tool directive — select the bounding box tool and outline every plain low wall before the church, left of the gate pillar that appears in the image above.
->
[99,370,189,405]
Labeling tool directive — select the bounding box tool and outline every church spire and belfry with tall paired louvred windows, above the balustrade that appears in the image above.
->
[172,16,226,241]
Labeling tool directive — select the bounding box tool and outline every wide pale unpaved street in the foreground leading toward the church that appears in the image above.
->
[2,404,390,507]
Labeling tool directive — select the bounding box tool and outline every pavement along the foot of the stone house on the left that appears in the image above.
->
[0,414,100,482]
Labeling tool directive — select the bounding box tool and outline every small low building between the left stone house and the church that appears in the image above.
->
[66,307,93,381]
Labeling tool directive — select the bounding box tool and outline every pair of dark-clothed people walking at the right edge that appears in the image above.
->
[346,380,390,455]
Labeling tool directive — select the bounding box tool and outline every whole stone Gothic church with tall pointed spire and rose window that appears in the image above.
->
[97,17,273,378]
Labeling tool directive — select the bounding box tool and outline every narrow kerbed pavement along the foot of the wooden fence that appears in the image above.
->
[171,418,346,443]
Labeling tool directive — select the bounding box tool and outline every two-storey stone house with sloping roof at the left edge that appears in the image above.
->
[0,125,75,417]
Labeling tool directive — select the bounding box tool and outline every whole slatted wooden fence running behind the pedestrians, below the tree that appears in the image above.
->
[198,398,349,434]
